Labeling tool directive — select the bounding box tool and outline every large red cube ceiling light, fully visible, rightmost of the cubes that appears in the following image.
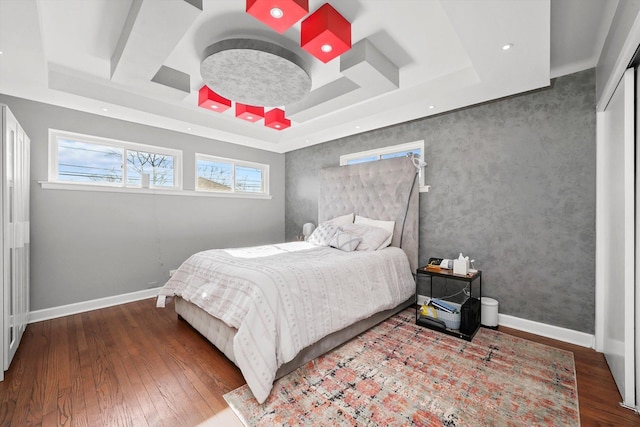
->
[300,3,351,63]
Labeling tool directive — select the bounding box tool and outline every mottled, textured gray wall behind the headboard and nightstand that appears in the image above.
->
[285,69,596,333]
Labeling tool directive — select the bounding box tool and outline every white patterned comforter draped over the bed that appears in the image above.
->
[158,242,415,403]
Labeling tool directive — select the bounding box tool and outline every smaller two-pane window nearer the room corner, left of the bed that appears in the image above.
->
[196,154,269,195]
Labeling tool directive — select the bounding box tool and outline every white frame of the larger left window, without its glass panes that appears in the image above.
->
[48,129,183,192]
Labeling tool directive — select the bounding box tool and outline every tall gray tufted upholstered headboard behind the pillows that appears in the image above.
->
[318,157,419,273]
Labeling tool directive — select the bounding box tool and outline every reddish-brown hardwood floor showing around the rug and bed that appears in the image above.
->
[0,299,640,427]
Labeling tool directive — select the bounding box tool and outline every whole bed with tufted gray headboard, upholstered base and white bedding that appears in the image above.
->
[158,157,418,403]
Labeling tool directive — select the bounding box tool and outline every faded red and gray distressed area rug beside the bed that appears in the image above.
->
[224,309,580,426]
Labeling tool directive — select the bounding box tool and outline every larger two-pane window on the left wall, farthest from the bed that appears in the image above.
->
[49,130,182,190]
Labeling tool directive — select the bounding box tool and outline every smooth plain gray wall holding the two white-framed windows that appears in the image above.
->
[0,95,284,311]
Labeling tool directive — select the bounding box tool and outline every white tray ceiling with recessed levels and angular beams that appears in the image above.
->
[0,0,618,153]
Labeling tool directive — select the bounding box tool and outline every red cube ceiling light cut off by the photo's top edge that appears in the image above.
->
[247,0,309,34]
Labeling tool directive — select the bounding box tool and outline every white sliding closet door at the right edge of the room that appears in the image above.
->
[596,69,636,408]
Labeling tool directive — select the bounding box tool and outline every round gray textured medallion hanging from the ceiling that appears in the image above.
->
[200,39,311,107]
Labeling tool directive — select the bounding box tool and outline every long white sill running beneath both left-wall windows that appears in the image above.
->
[38,181,271,199]
